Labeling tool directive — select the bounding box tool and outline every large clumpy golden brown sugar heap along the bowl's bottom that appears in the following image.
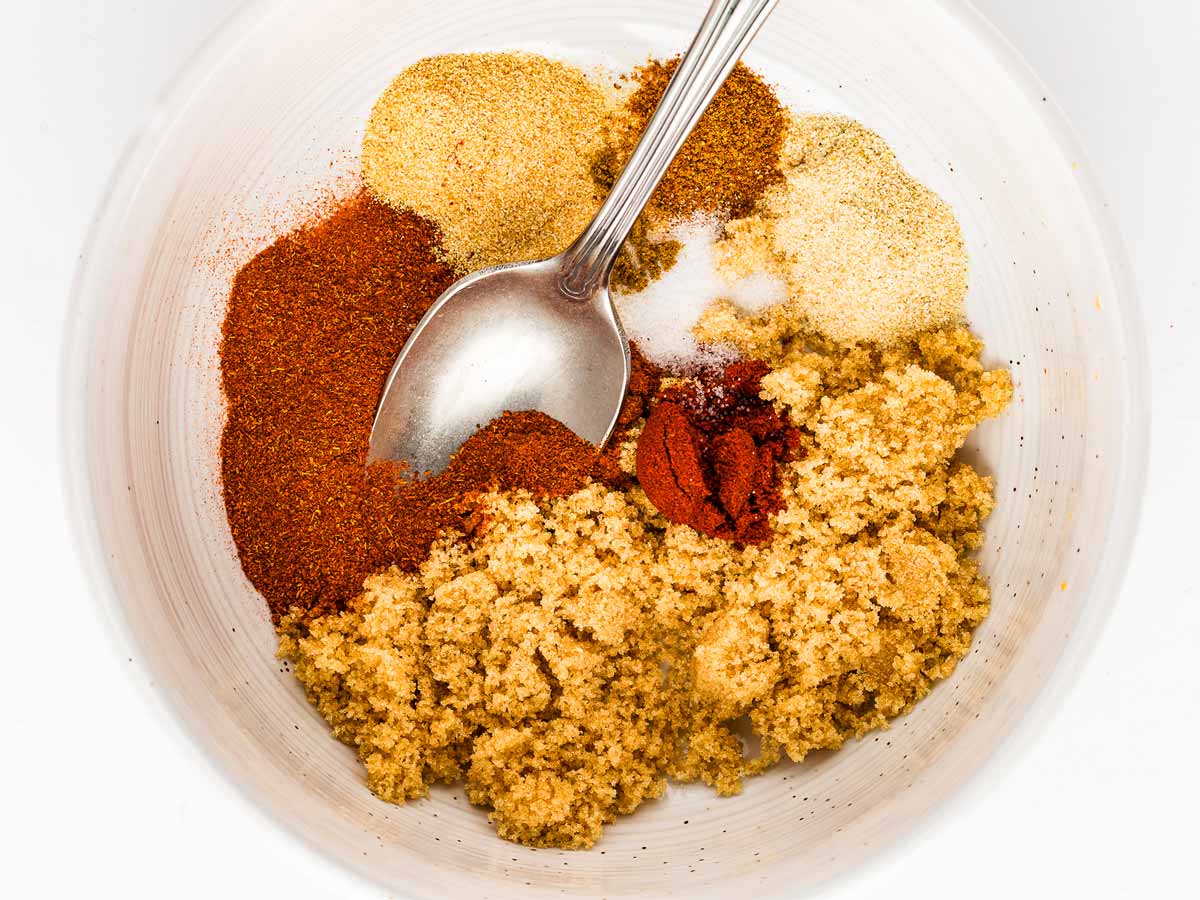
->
[280,329,1012,847]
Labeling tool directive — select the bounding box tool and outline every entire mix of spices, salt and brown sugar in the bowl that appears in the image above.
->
[221,53,1012,848]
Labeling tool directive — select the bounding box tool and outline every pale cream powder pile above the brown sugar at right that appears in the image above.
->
[716,115,967,342]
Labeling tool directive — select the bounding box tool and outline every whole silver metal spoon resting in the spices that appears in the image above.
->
[370,0,778,475]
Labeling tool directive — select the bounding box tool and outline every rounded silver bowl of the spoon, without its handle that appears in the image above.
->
[371,256,629,475]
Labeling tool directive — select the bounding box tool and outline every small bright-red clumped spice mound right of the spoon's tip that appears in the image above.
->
[637,360,800,544]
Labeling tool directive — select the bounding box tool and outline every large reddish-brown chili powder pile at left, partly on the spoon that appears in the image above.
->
[221,196,658,619]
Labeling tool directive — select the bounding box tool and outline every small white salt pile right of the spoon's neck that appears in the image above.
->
[616,216,787,367]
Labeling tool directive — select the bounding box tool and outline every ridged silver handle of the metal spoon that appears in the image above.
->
[559,0,779,300]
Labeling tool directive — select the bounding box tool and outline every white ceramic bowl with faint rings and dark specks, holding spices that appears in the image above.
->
[64,0,1147,898]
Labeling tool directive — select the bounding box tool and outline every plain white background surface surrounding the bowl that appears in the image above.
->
[0,0,1200,900]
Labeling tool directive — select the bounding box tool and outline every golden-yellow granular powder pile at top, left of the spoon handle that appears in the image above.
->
[362,53,612,271]
